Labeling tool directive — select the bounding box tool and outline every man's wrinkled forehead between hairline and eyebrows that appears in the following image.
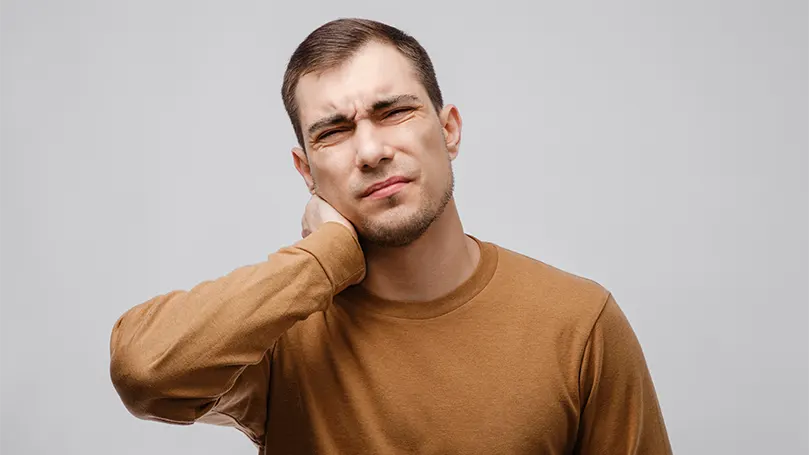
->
[295,42,426,126]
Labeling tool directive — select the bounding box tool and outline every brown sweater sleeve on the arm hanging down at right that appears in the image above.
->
[574,295,672,455]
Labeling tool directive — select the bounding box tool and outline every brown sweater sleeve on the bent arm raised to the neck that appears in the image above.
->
[110,223,365,447]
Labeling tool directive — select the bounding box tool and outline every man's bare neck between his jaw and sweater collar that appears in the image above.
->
[361,199,480,301]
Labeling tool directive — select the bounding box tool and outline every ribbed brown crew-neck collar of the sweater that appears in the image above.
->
[340,234,497,319]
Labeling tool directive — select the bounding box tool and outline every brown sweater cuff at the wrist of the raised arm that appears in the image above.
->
[295,221,365,295]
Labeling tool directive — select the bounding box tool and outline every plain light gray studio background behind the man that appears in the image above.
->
[0,1,809,455]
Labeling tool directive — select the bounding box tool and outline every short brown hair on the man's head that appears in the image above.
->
[281,18,444,149]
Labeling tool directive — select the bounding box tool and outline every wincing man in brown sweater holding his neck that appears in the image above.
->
[111,16,671,454]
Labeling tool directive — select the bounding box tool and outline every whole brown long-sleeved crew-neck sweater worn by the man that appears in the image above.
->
[110,223,671,455]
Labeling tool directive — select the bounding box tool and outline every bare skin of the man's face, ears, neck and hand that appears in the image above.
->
[292,42,480,301]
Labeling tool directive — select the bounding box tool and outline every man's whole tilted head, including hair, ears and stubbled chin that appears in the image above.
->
[282,19,461,246]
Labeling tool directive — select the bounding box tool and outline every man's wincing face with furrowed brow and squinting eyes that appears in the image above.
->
[294,43,461,246]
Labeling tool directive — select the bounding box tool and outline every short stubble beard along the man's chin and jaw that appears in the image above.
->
[357,165,455,248]
